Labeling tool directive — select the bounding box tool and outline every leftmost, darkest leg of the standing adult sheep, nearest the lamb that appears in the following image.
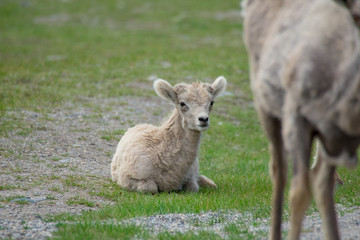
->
[257,107,287,239]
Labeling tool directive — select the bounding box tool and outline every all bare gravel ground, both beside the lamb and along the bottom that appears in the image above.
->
[0,88,360,239]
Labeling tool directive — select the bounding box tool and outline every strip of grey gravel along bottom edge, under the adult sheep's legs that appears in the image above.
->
[112,205,360,240]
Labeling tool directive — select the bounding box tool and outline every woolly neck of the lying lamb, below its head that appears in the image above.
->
[162,109,201,152]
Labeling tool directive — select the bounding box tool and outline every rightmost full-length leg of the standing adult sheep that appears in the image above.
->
[311,144,340,239]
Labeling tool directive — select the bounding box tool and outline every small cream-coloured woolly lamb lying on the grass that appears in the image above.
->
[111,77,226,193]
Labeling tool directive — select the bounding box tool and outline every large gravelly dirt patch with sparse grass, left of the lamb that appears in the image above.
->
[0,96,172,239]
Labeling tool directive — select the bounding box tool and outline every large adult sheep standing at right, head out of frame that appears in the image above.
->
[244,0,360,239]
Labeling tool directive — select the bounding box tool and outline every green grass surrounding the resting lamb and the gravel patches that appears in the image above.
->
[0,0,360,239]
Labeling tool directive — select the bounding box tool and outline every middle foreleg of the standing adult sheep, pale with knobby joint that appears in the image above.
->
[283,102,312,239]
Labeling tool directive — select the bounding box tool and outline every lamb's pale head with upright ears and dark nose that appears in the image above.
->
[154,76,226,131]
